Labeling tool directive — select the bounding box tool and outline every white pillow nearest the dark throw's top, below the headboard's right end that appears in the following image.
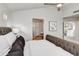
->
[4,32,16,47]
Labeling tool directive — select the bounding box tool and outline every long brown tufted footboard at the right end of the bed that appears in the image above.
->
[46,35,79,56]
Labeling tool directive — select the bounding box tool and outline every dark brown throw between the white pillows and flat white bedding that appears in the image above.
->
[7,36,25,56]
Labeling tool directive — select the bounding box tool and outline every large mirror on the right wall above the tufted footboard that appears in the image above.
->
[64,18,79,42]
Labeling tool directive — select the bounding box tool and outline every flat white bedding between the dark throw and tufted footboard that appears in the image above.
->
[24,40,73,56]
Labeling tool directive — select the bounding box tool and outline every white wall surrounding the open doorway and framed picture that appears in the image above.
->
[8,7,63,40]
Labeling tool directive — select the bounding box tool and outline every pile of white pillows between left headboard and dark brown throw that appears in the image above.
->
[0,32,16,56]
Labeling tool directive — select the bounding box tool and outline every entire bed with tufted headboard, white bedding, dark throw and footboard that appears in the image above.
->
[0,27,79,56]
